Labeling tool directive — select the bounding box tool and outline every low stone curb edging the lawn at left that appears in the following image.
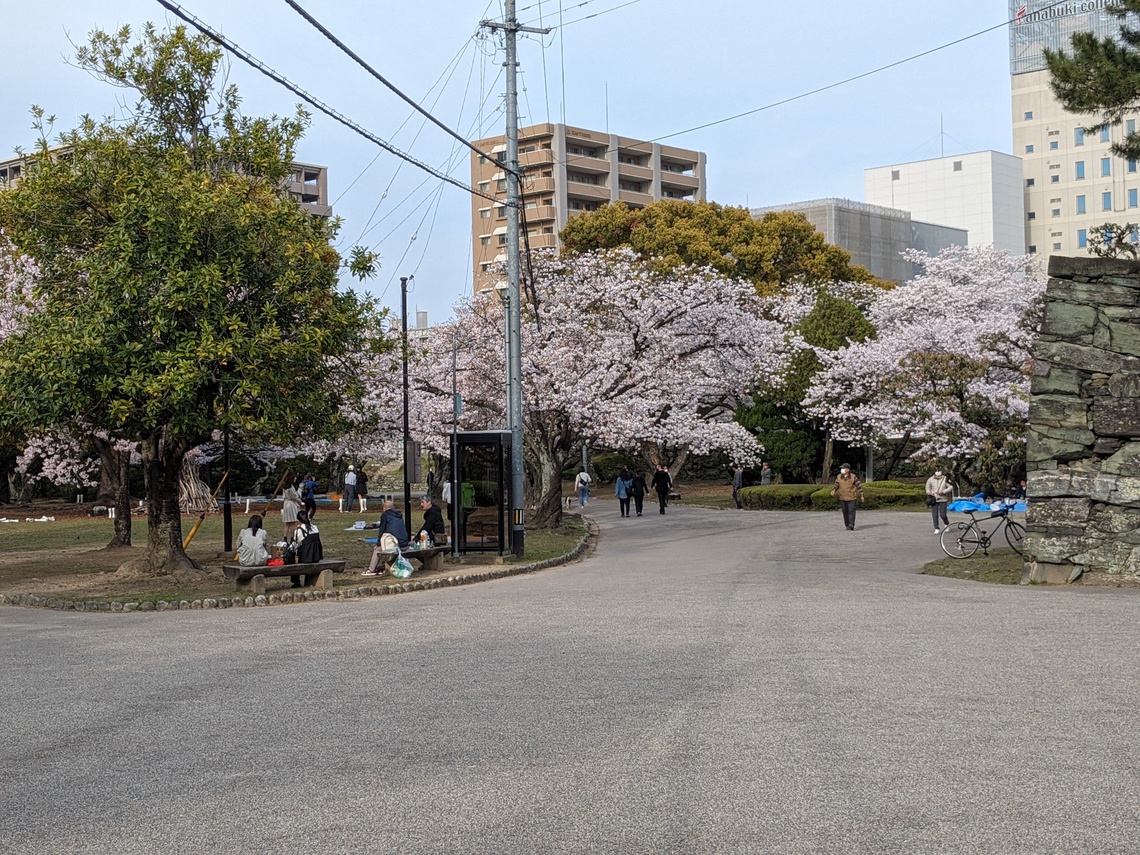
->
[0,516,599,613]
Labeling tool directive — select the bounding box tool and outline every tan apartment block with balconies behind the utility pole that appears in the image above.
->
[471,123,706,291]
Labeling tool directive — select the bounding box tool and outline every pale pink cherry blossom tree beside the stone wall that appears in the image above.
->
[805,247,1044,483]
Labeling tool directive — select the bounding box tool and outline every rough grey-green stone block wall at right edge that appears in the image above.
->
[1024,255,1140,583]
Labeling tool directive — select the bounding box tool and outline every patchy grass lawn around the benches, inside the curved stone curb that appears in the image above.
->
[0,507,586,602]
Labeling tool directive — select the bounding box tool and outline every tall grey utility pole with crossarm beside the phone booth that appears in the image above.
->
[481,0,549,556]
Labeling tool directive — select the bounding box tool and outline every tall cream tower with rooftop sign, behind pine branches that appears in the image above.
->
[1009,0,1140,255]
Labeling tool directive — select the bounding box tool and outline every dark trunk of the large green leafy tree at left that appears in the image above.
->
[124,433,196,576]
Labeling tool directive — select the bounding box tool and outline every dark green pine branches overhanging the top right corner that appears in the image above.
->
[1045,0,1140,160]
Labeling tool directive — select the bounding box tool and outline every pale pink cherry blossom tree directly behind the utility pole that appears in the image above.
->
[351,250,787,528]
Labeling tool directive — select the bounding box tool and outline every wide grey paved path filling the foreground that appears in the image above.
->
[0,513,1140,855]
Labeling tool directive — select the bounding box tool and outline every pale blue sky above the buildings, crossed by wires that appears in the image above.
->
[0,0,1011,323]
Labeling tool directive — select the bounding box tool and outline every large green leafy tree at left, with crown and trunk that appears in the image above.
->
[0,25,381,573]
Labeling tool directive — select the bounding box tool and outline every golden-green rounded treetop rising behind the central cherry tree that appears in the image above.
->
[560,200,877,294]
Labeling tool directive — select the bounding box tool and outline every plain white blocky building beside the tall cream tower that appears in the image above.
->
[863,152,1025,253]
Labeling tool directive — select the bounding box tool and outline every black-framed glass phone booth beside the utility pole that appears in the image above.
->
[451,431,511,555]
